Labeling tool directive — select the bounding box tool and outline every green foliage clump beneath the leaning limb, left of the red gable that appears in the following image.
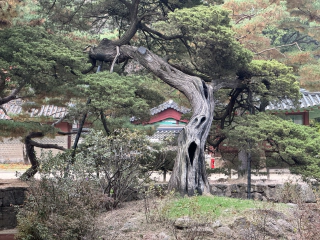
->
[81,72,164,134]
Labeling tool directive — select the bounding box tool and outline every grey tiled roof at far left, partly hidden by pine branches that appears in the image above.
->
[0,101,67,119]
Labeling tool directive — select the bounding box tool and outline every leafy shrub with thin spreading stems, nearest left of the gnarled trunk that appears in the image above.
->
[80,129,154,208]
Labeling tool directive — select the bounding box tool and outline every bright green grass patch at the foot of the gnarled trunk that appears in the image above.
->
[168,196,285,219]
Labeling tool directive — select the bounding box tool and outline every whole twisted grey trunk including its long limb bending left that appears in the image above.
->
[100,45,214,196]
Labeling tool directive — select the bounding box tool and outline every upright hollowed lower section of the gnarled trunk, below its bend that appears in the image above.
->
[169,88,214,196]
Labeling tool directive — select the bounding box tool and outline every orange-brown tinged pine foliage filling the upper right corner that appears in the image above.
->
[223,0,319,90]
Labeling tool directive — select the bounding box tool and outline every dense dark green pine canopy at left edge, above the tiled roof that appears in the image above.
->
[0,26,85,104]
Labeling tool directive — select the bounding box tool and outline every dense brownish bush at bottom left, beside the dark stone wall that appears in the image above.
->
[16,154,103,240]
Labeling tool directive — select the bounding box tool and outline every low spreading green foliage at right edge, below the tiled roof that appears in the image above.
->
[226,113,320,179]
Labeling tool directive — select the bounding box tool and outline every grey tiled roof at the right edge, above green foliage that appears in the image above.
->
[266,89,320,111]
